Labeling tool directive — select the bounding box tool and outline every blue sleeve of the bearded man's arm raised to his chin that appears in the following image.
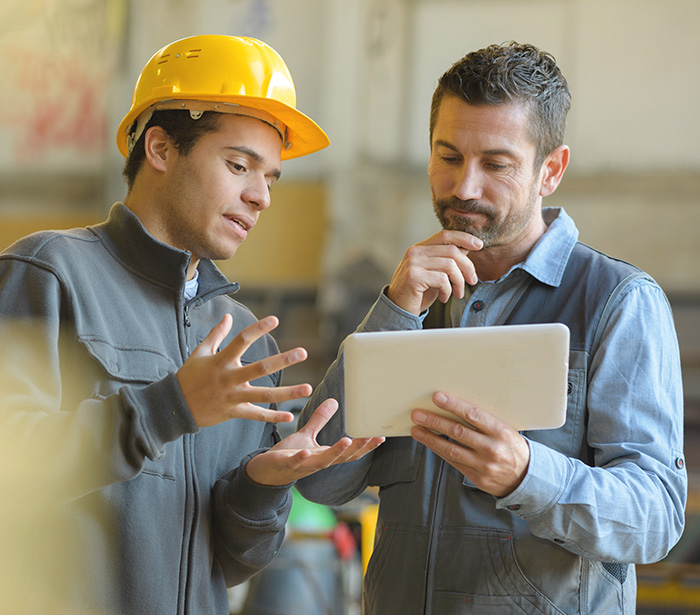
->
[296,291,425,506]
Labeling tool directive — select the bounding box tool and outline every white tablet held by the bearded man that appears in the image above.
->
[344,323,569,438]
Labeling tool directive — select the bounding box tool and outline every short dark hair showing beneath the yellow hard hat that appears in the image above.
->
[122,109,221,190]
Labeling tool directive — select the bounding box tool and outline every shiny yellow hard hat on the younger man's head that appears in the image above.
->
[117,34,330,160]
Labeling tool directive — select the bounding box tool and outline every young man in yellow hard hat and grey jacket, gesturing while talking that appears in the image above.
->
[0,36,382,615]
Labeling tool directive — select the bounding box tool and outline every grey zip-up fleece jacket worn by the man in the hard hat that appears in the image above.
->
[0,204,291,615]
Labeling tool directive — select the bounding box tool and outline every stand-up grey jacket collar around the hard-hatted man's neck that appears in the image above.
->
[88,203,239,296]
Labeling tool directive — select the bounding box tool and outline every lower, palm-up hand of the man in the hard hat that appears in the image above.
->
[246,399,384,485]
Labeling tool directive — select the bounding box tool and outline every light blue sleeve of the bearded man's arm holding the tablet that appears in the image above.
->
[497,281,687,563]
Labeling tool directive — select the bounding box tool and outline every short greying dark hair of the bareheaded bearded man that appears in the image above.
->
[430,41,571,166]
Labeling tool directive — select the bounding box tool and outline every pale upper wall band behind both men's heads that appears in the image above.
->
[6,0,700,176]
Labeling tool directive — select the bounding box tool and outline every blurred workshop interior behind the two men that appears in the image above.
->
[0,0,700,613]
